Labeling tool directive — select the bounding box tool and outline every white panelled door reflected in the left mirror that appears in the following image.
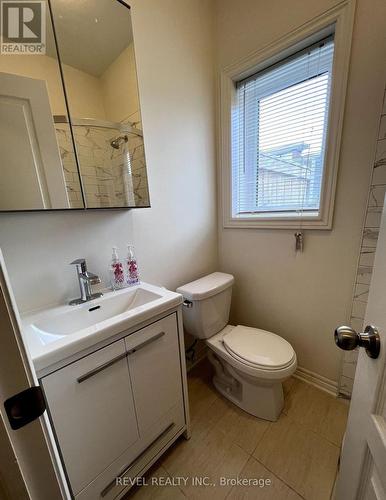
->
[0,73,69,210]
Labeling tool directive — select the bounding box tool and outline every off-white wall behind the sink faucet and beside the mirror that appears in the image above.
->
[0,0,217,310]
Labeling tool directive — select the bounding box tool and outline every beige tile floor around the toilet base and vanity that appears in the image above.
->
[127,360,348,500]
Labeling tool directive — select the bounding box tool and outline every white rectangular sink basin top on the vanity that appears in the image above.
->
[22,283,182,371]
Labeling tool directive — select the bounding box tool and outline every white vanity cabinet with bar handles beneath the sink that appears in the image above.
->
[40,313,187,500]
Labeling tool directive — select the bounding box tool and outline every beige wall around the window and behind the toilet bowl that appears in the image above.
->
[216,0,386,381]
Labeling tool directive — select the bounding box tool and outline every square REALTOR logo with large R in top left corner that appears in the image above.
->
[0,0,46,55]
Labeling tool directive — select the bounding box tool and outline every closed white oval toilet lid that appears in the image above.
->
[223,325,295,370]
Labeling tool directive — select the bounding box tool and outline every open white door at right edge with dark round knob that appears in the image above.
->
[335,201,386,500]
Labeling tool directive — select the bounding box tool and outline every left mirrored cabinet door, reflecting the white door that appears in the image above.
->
[0,3,84,211]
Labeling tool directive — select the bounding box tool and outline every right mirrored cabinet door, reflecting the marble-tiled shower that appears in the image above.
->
[51,0,150,208]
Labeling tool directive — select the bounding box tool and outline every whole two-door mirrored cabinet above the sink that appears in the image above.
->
[0,0,150,211]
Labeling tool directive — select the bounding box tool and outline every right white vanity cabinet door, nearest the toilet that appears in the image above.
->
[125,314,183,437]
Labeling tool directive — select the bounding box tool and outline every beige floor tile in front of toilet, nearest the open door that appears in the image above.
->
[254,414,339,500]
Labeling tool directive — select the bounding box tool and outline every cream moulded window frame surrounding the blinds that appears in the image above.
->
[219,0,354,230]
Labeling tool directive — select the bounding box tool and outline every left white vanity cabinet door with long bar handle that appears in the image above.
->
[42,339,139,495]
